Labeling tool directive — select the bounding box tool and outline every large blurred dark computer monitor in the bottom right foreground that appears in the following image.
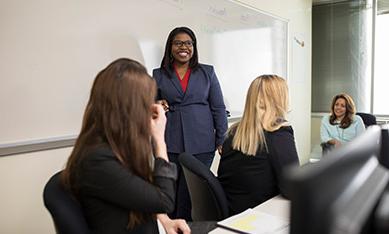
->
[285,126,389,234]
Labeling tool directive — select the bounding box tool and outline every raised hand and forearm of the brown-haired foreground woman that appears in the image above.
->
[151,104,169,161]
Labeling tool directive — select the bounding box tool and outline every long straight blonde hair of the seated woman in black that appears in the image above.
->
[229,75,289,156]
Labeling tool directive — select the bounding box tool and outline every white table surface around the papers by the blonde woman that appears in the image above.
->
[209,195,290,234]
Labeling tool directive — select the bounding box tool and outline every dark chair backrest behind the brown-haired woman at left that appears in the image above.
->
[43,171,90,234]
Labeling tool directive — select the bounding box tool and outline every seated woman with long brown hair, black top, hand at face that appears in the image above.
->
[62,58,190,234]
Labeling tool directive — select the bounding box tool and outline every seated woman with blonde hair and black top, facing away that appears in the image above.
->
[218,75,299,215]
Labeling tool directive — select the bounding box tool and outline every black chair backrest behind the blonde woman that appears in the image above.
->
[179,153,228,221]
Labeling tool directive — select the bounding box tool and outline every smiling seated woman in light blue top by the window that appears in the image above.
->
[320,93,365,147]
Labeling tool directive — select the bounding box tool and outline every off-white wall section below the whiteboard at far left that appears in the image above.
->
[0,148,70,234]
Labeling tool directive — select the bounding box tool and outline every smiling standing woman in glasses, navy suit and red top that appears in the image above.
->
[153,27,227,220]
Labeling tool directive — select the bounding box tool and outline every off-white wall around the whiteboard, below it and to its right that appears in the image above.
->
[0,0,311,234]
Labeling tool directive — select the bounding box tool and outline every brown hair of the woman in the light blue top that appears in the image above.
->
[330,93,356,128]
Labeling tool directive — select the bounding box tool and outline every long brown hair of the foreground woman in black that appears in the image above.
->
[62,58,156,228]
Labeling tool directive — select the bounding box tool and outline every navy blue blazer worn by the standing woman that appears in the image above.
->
[153,64,227,154]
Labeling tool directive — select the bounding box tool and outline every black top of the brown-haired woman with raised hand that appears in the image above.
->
[76,148,177,234]
